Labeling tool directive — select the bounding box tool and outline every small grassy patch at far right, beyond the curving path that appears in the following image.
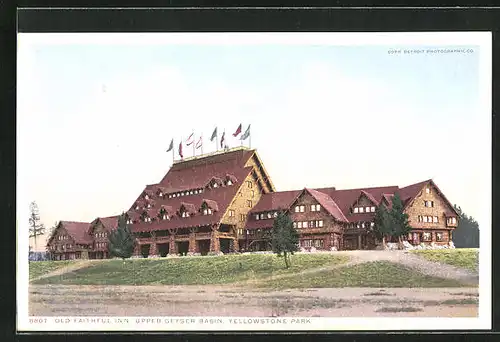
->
[411,248,479,271]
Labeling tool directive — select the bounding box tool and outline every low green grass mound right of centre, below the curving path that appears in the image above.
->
[259,261,465,289]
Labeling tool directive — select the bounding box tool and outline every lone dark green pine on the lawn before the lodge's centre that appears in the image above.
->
[271,211,299,268]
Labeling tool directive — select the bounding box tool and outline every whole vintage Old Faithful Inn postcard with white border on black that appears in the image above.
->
[17,32,491,331]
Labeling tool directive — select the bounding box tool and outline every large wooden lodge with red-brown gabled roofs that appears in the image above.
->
[48,147,458,260]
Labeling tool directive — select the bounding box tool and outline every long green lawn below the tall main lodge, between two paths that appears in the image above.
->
[34,254,348,285]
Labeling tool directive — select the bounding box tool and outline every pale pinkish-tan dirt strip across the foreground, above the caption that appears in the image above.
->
[29,285,478,317]
